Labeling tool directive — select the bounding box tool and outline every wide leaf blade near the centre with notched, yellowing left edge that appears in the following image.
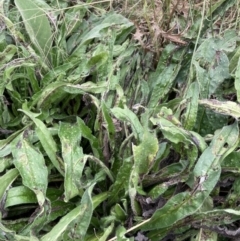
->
[132,131,158,174]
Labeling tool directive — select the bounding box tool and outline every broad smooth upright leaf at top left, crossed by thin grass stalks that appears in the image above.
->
[15,0,53,62]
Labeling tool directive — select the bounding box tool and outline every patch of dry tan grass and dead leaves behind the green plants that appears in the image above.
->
[111,0,240,56]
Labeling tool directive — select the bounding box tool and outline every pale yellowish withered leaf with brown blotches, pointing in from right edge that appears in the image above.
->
[199,99,240,119]
